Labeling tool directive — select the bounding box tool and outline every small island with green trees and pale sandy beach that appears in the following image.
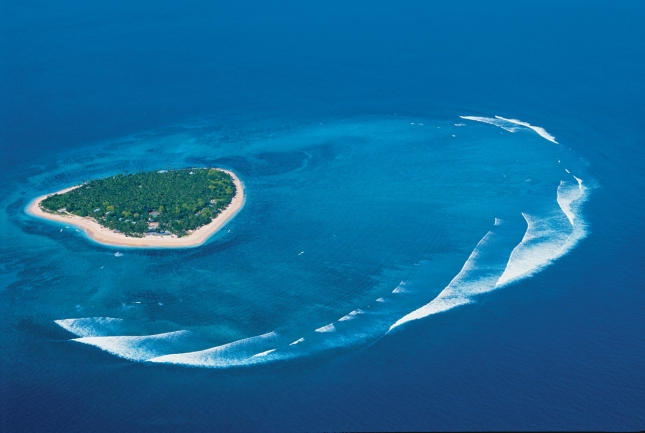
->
[27,168,244,247]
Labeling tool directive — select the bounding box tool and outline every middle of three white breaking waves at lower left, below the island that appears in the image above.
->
[73,331,190,361]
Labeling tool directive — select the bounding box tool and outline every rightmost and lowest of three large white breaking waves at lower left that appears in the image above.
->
[147,332,278,368]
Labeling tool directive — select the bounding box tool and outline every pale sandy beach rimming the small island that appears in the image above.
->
[26,168,245,248]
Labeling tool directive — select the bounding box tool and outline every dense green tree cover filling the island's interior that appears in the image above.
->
[41,168,236,237]
